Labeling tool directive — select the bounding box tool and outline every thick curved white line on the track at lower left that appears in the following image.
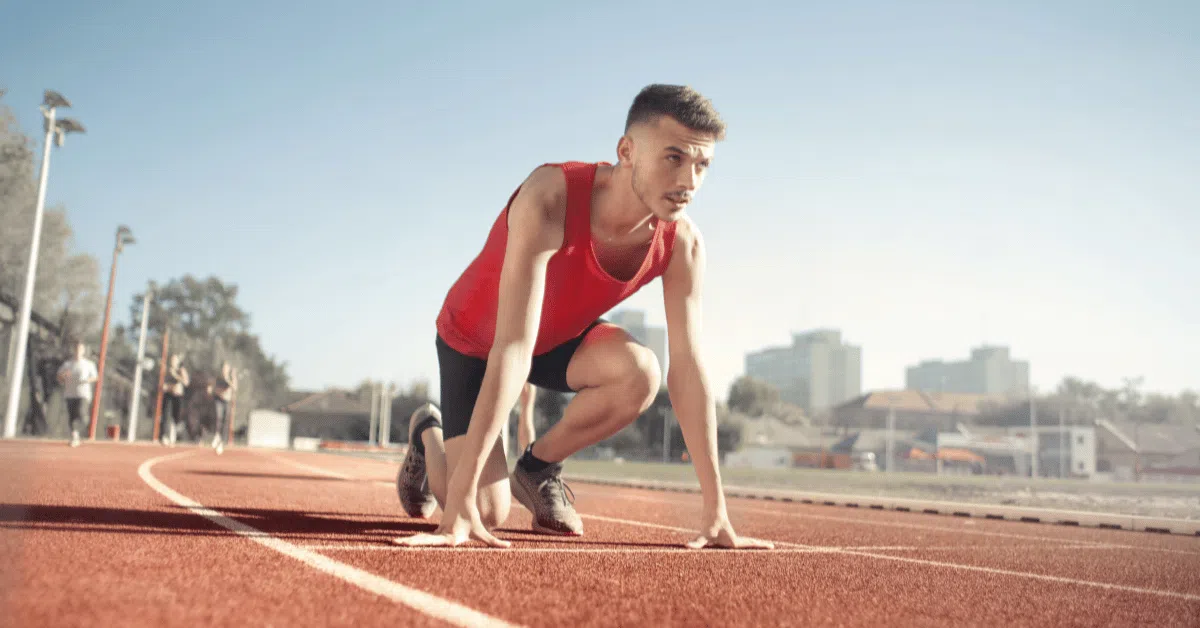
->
[138,451,512,626]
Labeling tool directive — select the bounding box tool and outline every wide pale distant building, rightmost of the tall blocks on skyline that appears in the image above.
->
[905,345,1030,397]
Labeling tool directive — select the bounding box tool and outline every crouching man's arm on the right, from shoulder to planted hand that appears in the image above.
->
[662,219,772,549]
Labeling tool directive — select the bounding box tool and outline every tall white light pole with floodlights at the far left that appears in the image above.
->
[4,90,84,438]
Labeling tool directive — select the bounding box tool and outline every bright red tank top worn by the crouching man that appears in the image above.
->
[437,162,676,358]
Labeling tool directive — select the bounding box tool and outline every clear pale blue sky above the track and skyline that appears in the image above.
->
[0,0,1200,395]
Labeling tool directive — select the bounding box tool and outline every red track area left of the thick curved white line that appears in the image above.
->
[0,442,444,627]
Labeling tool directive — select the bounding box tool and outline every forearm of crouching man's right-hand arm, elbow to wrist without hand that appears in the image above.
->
[667,360,725,513]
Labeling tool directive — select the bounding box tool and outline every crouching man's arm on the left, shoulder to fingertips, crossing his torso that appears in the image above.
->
[409,167,566,546]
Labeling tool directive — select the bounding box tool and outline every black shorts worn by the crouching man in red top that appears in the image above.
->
[437,319,606,439]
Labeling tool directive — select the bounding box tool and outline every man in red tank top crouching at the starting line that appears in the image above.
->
[396,85,772,549]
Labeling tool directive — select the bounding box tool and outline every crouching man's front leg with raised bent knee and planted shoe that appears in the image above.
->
[511,323,661,536]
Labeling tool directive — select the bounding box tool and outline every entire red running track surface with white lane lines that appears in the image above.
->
[0,442,1200,627]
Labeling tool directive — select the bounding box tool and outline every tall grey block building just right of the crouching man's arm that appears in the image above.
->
[745,329,863,414]
